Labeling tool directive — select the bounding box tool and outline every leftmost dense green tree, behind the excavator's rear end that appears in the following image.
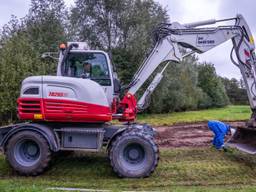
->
[0,19,41,123]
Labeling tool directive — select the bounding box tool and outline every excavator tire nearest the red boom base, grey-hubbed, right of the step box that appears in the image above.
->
[109,131,159,178]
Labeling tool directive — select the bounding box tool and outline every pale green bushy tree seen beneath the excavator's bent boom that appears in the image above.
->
[149,56,205,113]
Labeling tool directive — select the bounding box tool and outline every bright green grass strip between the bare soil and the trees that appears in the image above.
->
[138,105,251,126]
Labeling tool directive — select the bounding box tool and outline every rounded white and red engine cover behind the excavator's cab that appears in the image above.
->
[18,76,112,122]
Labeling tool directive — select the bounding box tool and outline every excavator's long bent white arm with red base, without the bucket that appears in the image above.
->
[118,15,256,127]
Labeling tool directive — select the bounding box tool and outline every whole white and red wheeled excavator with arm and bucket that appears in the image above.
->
[0,15,256,178]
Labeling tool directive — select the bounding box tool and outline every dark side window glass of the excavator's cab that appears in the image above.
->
[62,52,111,86]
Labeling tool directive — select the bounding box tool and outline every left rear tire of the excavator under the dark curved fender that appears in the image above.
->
[6,131,51,176]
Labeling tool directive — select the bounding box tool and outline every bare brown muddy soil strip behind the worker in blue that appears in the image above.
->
[156,122,244,148]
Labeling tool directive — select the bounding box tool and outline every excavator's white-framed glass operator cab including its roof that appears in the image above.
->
[57,42,118,106]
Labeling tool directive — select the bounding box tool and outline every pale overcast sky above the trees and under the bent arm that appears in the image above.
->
[0,0,256,78]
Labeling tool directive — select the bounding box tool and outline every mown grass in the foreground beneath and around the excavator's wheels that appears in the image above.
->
[0,147,256,192]
